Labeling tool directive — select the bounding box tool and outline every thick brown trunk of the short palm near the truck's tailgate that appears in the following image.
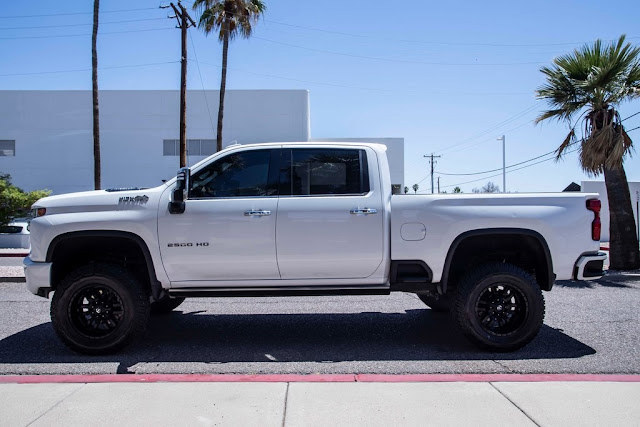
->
[604,167,640,270]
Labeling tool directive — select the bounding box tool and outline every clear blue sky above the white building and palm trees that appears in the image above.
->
[0,0,640,192]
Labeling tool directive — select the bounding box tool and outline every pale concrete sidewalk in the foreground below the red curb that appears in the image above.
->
[0,381,640,426]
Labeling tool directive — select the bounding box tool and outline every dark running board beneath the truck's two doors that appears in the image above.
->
[168,286,390,298]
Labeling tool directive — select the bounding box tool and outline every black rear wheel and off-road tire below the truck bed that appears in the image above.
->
[452,264,545,352]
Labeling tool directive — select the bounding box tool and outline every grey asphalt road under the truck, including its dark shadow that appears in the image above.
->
[0,259,640,374]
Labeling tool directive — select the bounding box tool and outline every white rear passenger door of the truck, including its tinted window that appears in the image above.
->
[276,148,384,279]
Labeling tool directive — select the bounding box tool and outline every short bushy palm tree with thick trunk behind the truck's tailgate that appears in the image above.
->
[536,35,640,270]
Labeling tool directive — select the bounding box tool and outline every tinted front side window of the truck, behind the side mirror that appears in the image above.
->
[189,150,272,199]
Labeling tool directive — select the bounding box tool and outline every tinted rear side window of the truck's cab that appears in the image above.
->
[281,149,369,195]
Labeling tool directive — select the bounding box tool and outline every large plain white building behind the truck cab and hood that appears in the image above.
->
[0,90,404,194]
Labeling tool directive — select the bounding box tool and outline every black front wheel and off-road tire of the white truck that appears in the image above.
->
[51,264,150,355]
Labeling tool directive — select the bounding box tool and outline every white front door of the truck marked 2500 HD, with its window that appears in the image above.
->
[158,149,280,287]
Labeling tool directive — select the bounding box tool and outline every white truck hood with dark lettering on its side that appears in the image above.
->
[32,185,166,215]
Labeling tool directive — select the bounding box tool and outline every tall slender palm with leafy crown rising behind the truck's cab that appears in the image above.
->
[193,0,266,151]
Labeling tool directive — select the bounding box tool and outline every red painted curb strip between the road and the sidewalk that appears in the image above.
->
[0,374,640,384]
